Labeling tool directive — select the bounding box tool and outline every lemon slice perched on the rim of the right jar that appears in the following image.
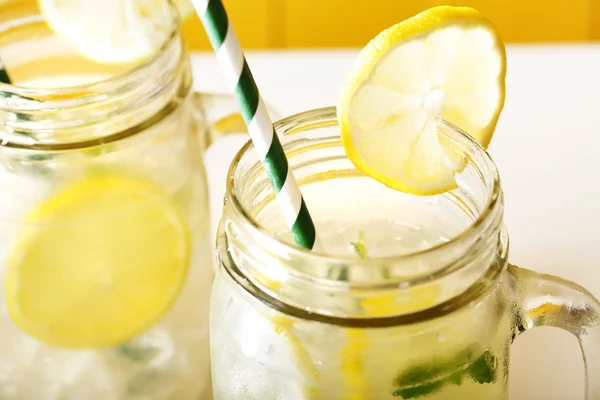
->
[337,6,506,195]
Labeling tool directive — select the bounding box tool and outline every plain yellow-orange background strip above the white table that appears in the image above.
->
[184,0,600,50]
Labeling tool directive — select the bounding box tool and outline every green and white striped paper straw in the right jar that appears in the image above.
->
[192,0,320,250]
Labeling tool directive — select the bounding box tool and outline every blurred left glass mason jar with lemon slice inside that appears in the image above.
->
[0,0,240,400]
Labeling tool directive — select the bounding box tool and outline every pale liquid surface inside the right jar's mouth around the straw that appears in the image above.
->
[257,177,472,257]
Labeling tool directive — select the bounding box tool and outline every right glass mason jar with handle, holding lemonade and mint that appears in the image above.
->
[210,108,600,400]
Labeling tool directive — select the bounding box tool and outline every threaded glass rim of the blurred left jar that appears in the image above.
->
[0,1,192,152]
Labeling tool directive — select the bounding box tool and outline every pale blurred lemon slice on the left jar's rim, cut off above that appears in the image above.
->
[38,0,194,64]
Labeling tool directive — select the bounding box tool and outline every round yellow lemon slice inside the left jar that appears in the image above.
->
[6,176,190,348]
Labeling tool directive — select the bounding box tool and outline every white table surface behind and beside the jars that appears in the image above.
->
[193,45,600,400]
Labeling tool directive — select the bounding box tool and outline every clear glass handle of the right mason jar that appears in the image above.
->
[508,265,600,400]
